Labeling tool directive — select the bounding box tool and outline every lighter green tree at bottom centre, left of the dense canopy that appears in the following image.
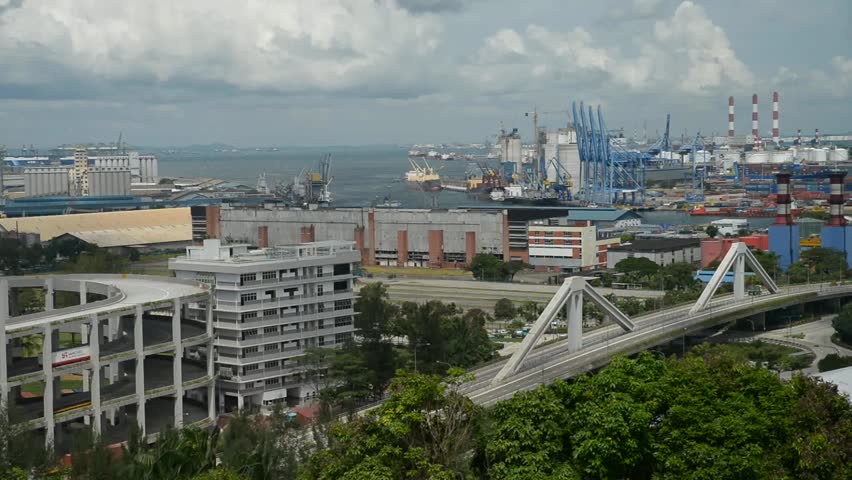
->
[302,369,480,480]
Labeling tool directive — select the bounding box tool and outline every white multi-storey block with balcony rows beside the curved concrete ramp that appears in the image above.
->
[169,239,361,411]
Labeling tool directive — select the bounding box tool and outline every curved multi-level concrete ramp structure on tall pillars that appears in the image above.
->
[0,274,216,453]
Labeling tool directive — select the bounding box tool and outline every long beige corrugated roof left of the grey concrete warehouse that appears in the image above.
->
[0,207,192,247]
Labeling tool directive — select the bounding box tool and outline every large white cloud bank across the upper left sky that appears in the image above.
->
[0,0,440,92]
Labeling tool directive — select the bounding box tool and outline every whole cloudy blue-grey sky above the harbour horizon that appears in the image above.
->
[0,0,852,146]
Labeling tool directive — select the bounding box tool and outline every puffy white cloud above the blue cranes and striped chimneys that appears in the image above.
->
[467,0,754,94]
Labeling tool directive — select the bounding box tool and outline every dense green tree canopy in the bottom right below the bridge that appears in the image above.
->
[475,349,852,480]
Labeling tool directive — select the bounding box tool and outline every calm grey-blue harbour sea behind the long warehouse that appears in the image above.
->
[156,146,772,228]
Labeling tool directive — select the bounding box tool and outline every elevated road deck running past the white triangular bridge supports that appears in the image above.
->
[462,284,852,405]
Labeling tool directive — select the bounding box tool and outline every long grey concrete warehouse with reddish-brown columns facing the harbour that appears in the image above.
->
[212,205,506,268]
